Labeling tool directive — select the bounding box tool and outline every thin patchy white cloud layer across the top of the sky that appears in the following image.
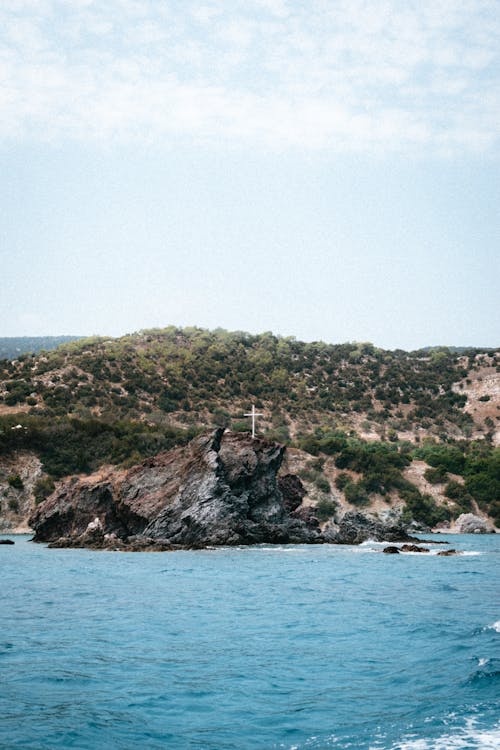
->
[0,0,500,153]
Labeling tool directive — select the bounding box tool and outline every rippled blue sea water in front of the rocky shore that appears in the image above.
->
[0,535,500,750]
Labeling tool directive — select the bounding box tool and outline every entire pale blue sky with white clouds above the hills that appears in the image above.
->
[0,0,500,350]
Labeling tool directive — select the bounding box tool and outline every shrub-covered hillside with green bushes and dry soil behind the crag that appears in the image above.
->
[0,327,500,524]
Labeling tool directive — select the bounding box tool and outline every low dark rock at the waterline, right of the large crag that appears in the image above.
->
[323,511,418,544]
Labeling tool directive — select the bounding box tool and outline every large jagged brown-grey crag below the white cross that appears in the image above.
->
[30,429,321,548]
